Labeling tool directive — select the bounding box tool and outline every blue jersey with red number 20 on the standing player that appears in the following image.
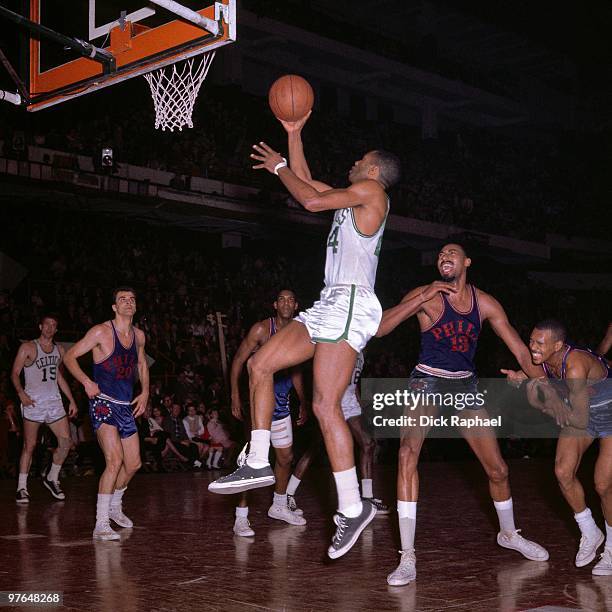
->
[93,321,138,402]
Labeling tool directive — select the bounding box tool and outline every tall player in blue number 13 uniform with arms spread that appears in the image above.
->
[377,244,548,586]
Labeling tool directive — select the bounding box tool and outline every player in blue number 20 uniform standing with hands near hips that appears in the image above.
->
[64,287,149,540]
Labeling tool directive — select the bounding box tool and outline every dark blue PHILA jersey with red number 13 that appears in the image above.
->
[416,285,481,378]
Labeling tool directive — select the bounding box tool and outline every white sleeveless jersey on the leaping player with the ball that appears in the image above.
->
[325,199,389,291]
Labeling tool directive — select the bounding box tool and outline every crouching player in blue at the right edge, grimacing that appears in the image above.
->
[513,320,612,576]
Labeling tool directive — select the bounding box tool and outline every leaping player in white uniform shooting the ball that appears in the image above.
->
[209,111,400,558]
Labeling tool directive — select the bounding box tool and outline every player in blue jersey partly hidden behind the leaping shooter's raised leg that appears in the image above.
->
[230,289,307,536]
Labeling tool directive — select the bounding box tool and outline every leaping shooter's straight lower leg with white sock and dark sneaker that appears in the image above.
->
[312,342,376,559]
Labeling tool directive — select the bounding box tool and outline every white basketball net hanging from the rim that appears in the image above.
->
[144,51,215,132]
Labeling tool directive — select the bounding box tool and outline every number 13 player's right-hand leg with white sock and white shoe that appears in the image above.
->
[460,409,548,561]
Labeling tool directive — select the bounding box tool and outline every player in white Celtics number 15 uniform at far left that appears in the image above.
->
[11,314,77,504]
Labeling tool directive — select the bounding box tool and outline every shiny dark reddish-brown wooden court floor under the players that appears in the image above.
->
[0,460,612,612]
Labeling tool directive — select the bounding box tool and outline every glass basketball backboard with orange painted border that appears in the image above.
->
[3,0,236,111]
